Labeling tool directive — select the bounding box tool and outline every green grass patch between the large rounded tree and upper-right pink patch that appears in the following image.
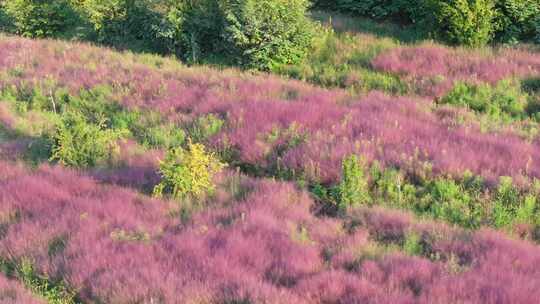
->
[273,14,410,95]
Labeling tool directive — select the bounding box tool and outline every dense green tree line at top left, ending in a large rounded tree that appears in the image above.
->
[0,0,314,70]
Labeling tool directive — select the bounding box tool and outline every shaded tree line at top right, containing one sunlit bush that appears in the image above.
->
[315,0,540,46]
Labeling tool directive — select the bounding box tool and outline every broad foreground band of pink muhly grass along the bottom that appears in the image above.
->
[0,163,540,303]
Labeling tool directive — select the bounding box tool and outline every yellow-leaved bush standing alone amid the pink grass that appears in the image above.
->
[154,141,225,199]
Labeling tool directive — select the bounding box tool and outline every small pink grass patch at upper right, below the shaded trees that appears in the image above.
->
[372,46,540,97]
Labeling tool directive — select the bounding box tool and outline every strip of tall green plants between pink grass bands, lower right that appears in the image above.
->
[309,158,540,236]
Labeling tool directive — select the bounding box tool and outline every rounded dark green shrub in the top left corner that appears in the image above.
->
[3,0,76,38]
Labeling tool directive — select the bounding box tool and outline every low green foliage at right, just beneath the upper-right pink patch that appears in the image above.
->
[439,80,528,121]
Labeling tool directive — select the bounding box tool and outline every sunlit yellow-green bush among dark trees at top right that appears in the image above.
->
[434,0,496,47]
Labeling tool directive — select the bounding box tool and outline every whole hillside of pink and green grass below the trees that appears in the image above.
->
[0,13,540,303]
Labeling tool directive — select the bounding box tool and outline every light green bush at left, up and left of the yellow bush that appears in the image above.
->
[50,112,119,168]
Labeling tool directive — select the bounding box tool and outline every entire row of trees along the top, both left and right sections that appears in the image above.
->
[0,0,540,70]
